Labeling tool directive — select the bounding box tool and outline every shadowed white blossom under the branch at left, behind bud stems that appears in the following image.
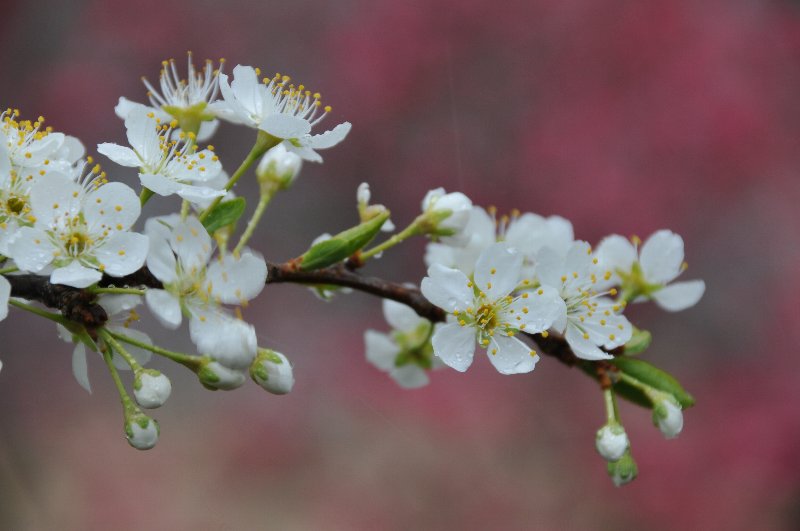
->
[57,294,153,393]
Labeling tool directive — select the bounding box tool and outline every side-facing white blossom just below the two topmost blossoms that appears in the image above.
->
[97,109,225,206]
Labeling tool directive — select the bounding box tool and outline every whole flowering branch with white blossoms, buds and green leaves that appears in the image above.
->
[0,54,705,484]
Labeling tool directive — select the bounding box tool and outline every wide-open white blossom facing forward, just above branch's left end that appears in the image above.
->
[9,174,147,288]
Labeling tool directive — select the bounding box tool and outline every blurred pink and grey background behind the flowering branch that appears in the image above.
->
[0,0,800,530]
